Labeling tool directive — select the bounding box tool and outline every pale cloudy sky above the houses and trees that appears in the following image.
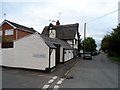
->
[0,0,119,45]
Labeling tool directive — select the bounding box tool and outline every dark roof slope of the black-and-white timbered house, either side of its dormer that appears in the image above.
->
[42,23,79,39]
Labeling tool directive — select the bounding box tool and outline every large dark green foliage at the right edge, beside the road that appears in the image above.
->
[101,25,120,56]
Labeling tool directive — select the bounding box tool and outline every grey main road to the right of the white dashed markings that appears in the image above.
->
[60,54,118,88]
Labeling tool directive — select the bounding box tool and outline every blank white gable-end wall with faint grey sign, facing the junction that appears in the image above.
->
[2,34,54,70]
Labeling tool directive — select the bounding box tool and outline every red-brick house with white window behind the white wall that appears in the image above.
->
[0,20,36,40]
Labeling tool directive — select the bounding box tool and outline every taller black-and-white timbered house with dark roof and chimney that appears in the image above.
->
[42,21,80,57]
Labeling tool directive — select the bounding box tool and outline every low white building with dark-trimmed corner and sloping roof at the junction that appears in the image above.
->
[1,33,73,71]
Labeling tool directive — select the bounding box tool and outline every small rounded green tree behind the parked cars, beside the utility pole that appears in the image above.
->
[82,37,97,52]
